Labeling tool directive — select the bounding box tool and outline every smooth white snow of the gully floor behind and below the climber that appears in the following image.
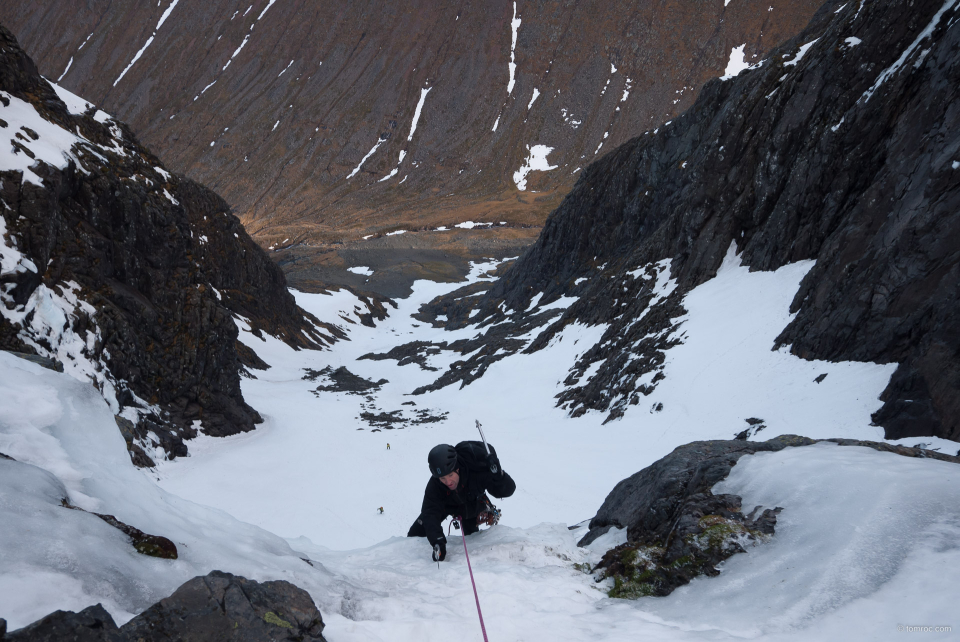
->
[160,248,916,549]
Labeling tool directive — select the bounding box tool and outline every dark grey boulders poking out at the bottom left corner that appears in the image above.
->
[0,571,324,642]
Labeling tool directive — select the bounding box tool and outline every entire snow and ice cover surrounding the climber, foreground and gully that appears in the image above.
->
[0,255,960,642]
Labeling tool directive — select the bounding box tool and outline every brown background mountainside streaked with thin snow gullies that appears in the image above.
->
[0,0,819,246]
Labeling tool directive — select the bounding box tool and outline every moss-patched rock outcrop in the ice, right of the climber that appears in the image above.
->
[579,435,960,598]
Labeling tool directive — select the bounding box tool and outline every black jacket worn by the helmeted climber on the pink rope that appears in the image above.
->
[418,441,517,546]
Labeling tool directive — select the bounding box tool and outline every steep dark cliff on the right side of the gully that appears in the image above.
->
[400,0,960,440]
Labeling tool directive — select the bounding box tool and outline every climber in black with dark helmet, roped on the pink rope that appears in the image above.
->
[407,441,517,562]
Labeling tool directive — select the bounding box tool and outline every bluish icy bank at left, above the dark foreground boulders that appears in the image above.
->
[0,352,338,630]
